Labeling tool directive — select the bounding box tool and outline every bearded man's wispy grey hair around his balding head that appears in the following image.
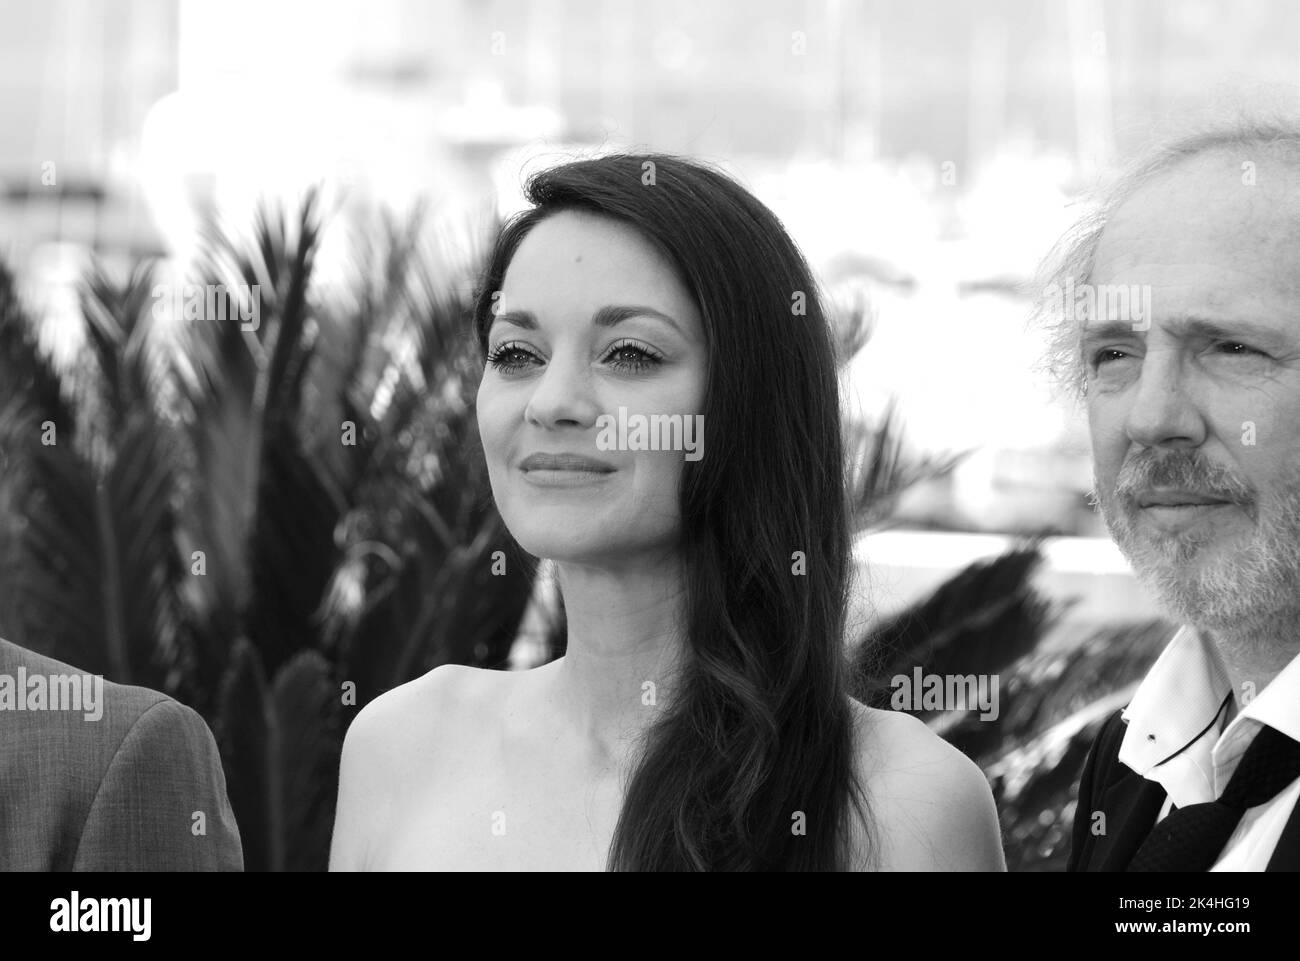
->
[1027,104,1300,401]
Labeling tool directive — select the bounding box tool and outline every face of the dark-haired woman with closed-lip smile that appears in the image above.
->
[478,211,706,566]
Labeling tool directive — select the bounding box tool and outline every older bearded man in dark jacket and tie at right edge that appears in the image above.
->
[1048,124,1300,871]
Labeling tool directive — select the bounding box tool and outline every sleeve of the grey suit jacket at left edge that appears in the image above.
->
[73,700,243,871]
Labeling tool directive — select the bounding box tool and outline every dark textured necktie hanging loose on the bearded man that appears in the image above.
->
[1128,727,1300,871]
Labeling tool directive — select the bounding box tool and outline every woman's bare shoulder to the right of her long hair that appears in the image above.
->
[850,700,1006,871]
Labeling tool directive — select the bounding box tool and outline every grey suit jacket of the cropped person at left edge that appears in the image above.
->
[0,640,243,871]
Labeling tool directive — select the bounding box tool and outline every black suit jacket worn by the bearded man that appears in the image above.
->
[1066,711,1300,871]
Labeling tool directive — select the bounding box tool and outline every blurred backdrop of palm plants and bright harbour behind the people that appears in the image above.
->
[0,0,1300,870]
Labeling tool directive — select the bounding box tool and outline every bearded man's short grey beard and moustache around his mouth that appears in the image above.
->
[1093,449,1300,635]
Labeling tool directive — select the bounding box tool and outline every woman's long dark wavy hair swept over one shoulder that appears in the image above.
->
[475,153,870,870]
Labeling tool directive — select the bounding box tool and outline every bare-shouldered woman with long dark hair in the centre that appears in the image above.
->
[330,155,1002,870]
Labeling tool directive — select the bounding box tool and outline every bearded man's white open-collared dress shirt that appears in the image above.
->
[1119,627,1300,871]
